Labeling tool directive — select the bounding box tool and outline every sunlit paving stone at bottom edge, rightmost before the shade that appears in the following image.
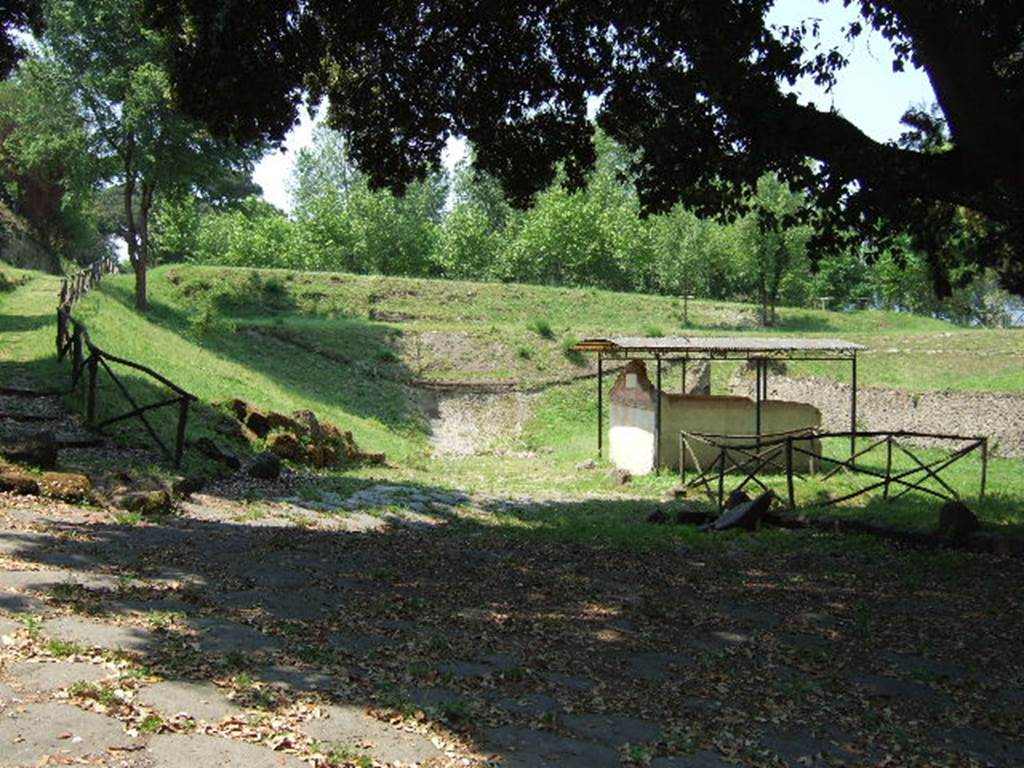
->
[302,705,443,765]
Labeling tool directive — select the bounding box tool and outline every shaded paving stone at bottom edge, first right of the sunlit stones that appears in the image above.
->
[483,726,621,768]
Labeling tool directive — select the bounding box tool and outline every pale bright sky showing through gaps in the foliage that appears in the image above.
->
[253,0,935,211]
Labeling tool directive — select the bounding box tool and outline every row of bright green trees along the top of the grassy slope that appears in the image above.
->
[155,127,1005,326]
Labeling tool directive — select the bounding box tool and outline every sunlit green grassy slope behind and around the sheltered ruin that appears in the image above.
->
[4,266,1024,536]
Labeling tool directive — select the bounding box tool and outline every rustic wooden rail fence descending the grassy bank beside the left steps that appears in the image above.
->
[56,257,197,467]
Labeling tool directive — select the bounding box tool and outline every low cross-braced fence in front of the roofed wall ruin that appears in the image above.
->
[679,429,988,510]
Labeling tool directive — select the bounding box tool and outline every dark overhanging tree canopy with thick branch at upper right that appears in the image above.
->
[150,0,1024,289]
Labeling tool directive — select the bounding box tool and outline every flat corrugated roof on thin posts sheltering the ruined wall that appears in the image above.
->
[573,336,864,357]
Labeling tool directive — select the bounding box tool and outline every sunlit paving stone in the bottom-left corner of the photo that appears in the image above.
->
[0,701,132,766]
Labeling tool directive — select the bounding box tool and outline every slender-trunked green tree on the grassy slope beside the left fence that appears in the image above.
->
[41,0,260,310]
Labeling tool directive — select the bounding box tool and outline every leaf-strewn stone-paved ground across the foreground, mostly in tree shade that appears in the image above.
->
[0,487,1024,768]
